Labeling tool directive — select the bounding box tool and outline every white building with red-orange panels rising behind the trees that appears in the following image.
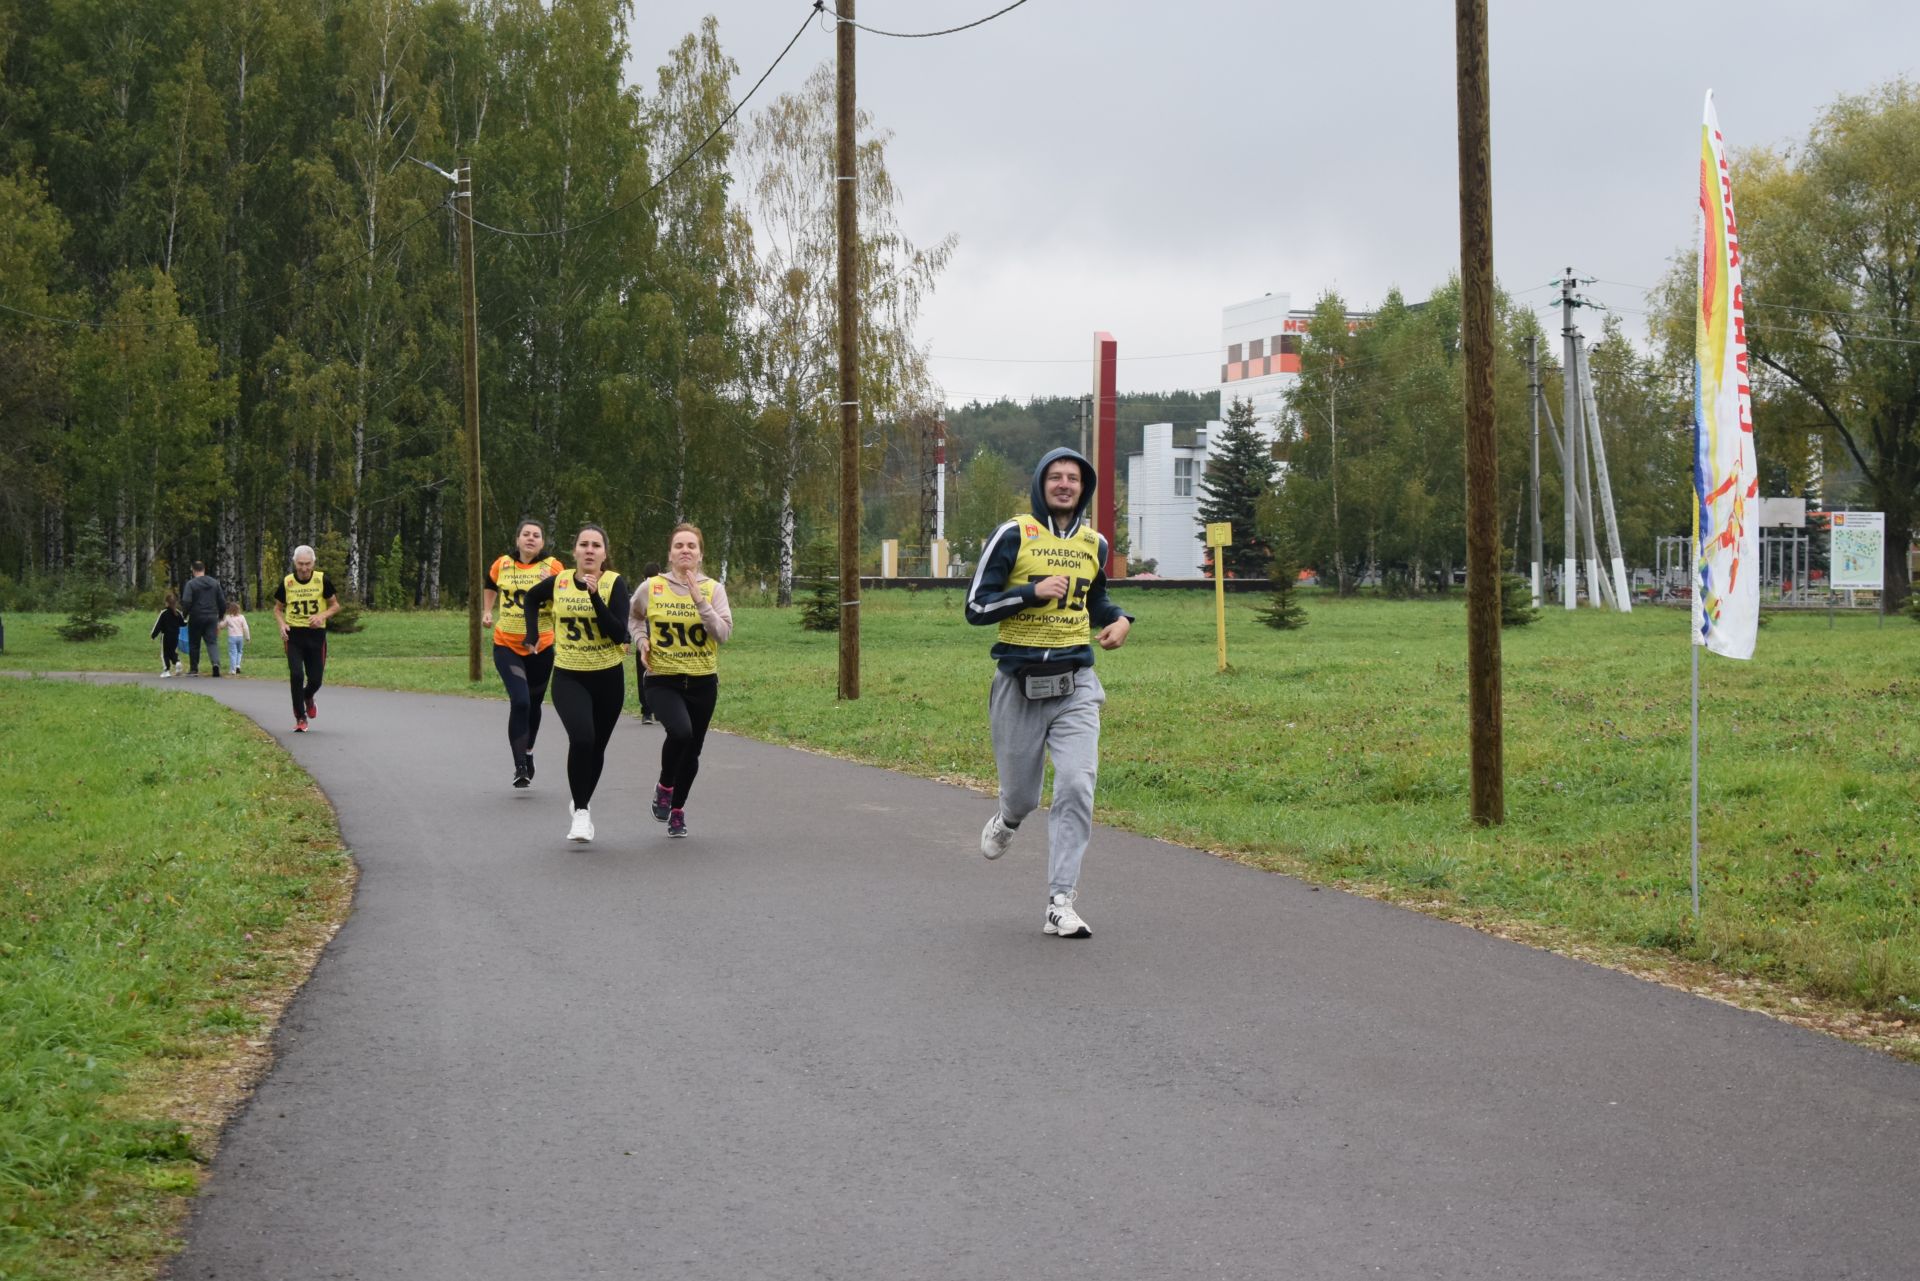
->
[1127,294,1367,578]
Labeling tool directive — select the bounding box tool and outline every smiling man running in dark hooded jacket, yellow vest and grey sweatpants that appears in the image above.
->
[966,449,1133,939]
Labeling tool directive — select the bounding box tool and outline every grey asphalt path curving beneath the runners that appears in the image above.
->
[86,680,1920,1281]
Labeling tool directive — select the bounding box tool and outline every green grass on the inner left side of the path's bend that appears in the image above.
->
[0,676,349,1281]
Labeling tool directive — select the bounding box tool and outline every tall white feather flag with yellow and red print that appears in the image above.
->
[1693,90,1761,659]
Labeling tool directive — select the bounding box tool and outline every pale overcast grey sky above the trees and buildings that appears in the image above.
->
[630,0,1920,403]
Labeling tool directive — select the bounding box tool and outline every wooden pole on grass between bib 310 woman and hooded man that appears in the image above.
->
[833,0,860,699]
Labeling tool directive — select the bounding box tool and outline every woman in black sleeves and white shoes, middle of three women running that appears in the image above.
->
[524,524,630,841]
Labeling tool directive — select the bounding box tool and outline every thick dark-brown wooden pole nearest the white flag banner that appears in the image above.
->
[1453,0,1507,826]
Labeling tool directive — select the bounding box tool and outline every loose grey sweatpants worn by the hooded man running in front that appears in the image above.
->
[987,666,1106,893]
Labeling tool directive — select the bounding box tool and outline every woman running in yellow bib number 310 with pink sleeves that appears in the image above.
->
[630,524,733,835]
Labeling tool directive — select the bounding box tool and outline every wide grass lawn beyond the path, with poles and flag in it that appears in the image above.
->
[0,590,1920,1052]
